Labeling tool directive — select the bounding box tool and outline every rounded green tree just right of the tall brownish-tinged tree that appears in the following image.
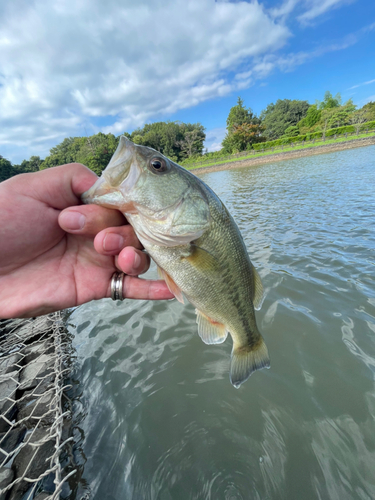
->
[260,99,310,140]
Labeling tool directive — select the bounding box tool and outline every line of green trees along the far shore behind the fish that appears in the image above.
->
[0,91,375,182]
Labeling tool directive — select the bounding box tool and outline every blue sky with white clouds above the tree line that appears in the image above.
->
[0,0,375,164]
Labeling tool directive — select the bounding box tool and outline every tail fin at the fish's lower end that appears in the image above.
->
[230,337,270,389]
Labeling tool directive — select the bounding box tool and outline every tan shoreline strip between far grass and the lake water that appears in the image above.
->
[189,136,375,175]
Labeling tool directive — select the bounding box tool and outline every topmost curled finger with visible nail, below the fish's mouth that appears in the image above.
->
[58,205,127,236]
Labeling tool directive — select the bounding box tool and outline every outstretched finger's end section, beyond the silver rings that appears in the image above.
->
[107,276,174,300]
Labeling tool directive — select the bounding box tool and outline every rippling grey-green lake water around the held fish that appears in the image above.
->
[70,146,375,500]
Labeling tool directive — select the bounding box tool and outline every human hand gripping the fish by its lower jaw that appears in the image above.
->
[0,163,173,318]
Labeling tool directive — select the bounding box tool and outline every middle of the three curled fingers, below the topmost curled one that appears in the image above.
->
[93,225,143,255]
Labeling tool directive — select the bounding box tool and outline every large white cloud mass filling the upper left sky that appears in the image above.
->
[0,0,290,161]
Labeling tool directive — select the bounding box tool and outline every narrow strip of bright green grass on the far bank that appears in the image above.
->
[185,131,375,170]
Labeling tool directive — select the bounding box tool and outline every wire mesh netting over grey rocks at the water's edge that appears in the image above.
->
[0,312,76,500]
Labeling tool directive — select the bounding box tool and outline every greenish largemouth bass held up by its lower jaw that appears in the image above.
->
[82,136,270,388]
